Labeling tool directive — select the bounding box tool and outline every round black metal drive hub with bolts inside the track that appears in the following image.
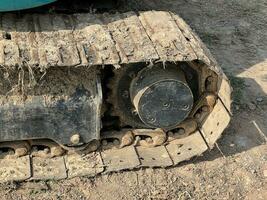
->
[130,65,193,129]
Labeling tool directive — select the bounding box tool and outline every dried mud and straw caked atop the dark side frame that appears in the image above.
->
[0,67,95,106]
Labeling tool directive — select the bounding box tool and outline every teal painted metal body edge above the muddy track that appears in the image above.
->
[0,0,57,12]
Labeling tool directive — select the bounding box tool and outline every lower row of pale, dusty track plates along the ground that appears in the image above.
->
[0,97,230,182]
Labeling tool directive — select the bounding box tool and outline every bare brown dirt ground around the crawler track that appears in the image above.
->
[0,0,267,200]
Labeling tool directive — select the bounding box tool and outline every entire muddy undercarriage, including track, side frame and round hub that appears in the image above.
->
[0,1,231,182]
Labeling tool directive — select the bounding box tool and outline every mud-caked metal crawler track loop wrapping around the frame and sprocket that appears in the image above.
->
[0,11,231,182]
